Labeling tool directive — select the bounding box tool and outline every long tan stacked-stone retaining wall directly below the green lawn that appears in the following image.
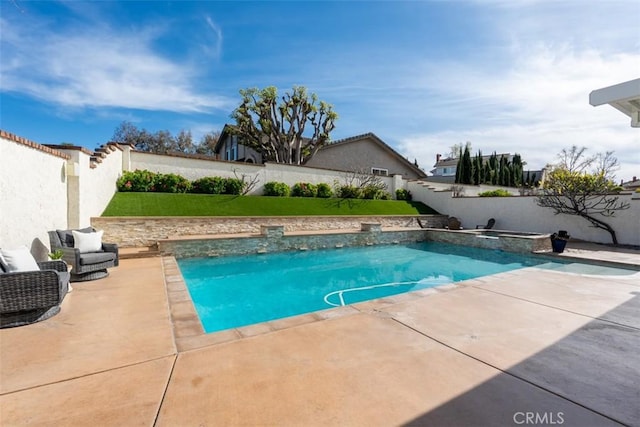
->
[91,215,447,247]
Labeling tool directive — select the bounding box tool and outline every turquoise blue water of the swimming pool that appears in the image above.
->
[178,242,636,333]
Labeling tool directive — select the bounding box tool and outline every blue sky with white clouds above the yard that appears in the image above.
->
[0,0,640,180]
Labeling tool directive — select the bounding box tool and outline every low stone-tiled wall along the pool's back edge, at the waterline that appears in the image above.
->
[158,224,427,258]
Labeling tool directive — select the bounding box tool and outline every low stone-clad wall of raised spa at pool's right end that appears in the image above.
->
[426,230,551,253]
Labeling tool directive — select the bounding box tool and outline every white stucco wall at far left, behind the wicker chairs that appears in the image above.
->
[0,137,67,252]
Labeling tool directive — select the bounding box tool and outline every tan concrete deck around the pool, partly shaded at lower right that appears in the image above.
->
[0,244,640,426]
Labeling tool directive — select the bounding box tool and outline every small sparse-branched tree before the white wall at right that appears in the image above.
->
[537,145,629,245]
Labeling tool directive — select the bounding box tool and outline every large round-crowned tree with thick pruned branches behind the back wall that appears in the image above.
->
[231,86,338,165]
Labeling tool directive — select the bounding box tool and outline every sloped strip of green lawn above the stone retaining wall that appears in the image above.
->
[102,193,437,216]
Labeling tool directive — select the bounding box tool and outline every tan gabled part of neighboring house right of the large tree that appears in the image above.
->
[306,132,427,179]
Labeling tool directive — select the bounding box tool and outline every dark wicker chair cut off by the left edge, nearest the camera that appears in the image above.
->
[0,261,69,328]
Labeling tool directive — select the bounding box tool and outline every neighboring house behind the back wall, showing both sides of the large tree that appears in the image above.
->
[215,125,426,179]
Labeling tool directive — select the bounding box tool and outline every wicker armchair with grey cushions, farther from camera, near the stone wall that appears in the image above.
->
[49,227,119,282]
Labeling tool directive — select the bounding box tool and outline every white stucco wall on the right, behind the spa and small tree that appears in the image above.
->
[408,182,640,245]
